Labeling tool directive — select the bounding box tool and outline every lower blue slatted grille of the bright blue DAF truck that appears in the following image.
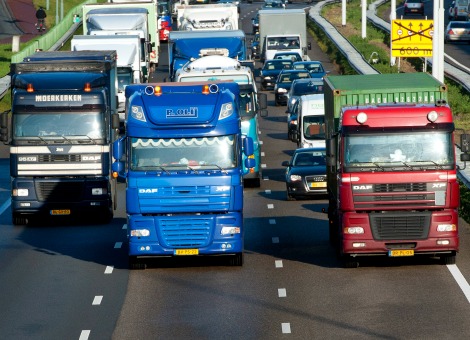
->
[160,216,213,248]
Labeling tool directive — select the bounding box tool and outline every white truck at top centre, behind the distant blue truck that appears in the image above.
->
[176,4,238,31]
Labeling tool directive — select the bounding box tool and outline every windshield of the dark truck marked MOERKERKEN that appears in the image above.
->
[13,112,105,141]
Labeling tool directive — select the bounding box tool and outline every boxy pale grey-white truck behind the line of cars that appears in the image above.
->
[259,9,311,62]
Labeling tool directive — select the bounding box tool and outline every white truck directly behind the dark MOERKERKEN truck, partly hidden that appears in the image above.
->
[71,35,148,117]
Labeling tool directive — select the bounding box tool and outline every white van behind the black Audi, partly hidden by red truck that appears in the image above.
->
[294,93,325,148]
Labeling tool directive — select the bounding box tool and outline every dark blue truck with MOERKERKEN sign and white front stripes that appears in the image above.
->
[0,51,119,225]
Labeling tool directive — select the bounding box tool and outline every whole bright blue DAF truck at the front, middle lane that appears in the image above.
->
[113,82,255,269]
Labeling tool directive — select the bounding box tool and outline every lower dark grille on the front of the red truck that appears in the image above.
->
[369,212,431,240]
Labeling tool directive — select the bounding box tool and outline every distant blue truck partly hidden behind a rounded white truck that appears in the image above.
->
[168,30,247,80]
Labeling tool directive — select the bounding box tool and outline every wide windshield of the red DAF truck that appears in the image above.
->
[344,132,454,171]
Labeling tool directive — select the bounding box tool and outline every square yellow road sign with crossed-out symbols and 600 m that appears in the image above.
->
[390,19,434,58]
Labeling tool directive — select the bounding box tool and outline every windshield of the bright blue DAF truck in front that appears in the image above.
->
[130,135,237,171]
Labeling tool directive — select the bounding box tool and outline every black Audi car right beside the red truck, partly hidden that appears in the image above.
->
[282,147,327,201]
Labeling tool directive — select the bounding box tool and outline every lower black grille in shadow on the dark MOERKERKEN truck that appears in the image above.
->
[35,182,84,202]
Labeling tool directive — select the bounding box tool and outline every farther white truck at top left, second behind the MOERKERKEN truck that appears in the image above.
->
[83,0,160,72]
